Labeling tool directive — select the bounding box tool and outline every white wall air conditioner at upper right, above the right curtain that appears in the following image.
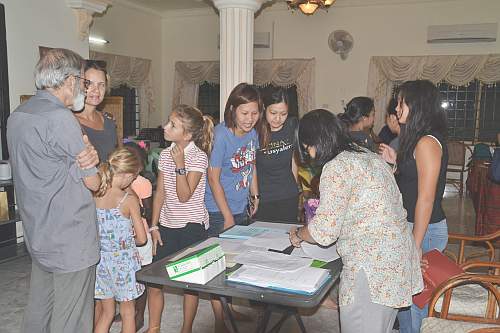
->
[427,23,498,43]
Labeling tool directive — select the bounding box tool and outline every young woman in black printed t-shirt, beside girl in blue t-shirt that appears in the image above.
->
[255,88,299,223]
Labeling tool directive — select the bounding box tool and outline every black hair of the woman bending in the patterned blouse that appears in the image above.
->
[297,109,363,166]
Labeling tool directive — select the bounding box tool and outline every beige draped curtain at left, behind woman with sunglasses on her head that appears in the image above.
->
[89,51,155,127]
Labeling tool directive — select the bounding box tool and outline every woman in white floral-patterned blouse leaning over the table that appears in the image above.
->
[290,109,423,333]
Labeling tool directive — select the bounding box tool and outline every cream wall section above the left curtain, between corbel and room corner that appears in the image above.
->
[90,1,164,126]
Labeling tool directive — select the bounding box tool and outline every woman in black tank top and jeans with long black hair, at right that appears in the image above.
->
[380,80,448,332]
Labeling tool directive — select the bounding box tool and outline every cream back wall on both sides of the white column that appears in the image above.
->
[162,0,500,124]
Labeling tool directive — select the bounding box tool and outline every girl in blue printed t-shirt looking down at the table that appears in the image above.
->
[205,83,263,236]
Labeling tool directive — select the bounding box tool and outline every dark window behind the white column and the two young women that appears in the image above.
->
[198,82,299,123]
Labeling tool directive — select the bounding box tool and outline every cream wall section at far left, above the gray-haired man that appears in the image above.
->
[2,0,89,112]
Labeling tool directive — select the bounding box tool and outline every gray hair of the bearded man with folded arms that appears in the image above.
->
[35,49,85,89]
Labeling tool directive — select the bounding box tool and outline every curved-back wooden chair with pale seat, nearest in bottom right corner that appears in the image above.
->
[420,272,500,333]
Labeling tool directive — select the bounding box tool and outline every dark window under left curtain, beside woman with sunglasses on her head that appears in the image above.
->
[110,85,141,137]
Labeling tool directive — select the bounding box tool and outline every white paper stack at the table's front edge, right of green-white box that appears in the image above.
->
[227,265,330,294]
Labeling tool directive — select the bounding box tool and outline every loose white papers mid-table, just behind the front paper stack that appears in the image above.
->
[234,250,312,272]
